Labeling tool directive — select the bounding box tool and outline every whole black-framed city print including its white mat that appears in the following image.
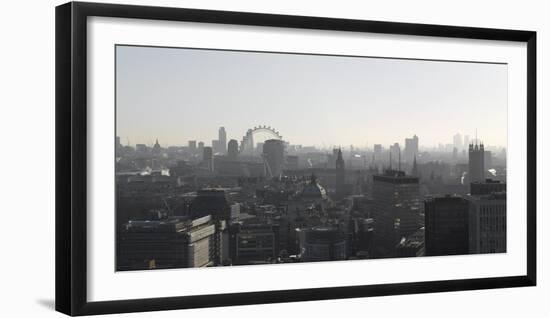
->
[56,2,536,315]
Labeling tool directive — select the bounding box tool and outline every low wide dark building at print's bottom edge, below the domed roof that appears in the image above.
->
[298,226,347,262]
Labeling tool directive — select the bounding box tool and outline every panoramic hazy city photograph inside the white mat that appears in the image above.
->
[113,45,508,271]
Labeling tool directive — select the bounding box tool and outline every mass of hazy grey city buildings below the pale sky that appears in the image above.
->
[115,126,506,270]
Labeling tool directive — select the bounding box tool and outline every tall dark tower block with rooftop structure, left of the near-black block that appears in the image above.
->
[372,170,421,258]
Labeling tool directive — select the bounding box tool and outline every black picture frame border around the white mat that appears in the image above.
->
[55,2,536,315]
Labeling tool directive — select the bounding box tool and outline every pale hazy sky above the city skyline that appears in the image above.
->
[116,46,508,147]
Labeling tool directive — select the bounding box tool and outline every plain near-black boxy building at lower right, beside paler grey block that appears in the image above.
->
[424,195,469,256]
